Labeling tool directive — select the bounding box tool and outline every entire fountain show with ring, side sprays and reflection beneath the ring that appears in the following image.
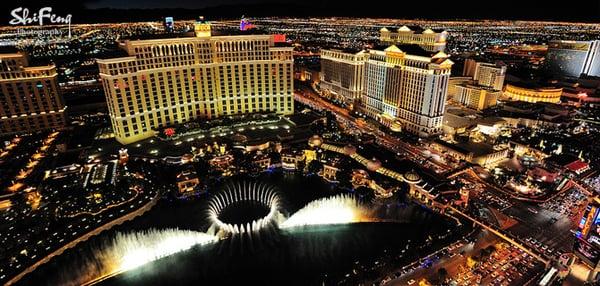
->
[24,181,375,285]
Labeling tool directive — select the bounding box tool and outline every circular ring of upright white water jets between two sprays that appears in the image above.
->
[208,181,285,237]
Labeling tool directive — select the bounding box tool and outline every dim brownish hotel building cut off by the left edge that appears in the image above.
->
[0,53,66,134]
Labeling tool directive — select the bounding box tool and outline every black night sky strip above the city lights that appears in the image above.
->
[0,0,600,24]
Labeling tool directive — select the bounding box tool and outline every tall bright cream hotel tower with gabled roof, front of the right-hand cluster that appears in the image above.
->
[361,45,453,137]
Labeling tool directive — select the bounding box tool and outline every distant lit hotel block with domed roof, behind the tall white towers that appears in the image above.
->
[379,26,448,52]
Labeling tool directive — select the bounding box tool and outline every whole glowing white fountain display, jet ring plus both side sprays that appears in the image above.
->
[75,182,375,285]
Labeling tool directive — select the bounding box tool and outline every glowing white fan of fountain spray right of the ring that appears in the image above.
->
[279,195,374,228]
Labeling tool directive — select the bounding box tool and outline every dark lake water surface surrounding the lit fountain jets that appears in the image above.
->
[20,174,454,285]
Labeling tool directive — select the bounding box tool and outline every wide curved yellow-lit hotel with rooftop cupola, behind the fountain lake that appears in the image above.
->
[98,25,294,144]
